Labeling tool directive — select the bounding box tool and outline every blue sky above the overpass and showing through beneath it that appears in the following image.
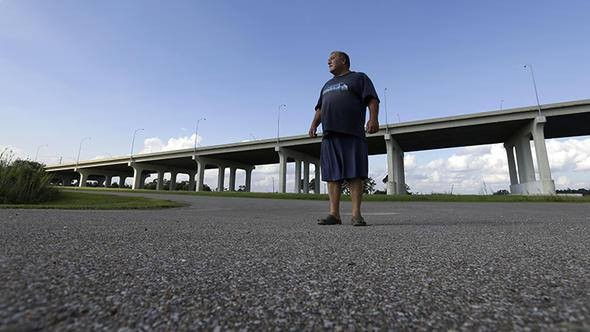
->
[0,0,590,192]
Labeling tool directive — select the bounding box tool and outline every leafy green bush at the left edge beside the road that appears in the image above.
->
[0,151,59,204]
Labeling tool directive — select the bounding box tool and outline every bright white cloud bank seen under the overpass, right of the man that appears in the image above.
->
[405,138,590,194]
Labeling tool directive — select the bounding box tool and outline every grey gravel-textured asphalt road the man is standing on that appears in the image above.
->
[0,195,590,331]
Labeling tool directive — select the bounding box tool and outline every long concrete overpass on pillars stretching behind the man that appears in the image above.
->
[47,99,590,195]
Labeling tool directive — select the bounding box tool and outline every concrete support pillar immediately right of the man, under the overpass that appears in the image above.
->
[385,134,406,195]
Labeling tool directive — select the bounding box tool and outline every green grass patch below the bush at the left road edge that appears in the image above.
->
[0,191,185,210]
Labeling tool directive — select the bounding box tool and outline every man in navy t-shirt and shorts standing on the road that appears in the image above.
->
[309,51,379,226]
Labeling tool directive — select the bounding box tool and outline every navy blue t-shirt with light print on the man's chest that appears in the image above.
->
[315,71,379,137]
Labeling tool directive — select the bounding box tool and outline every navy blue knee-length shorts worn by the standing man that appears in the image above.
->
[320,133,369,182]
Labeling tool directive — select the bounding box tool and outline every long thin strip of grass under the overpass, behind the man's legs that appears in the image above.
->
[63,187,590,203]
